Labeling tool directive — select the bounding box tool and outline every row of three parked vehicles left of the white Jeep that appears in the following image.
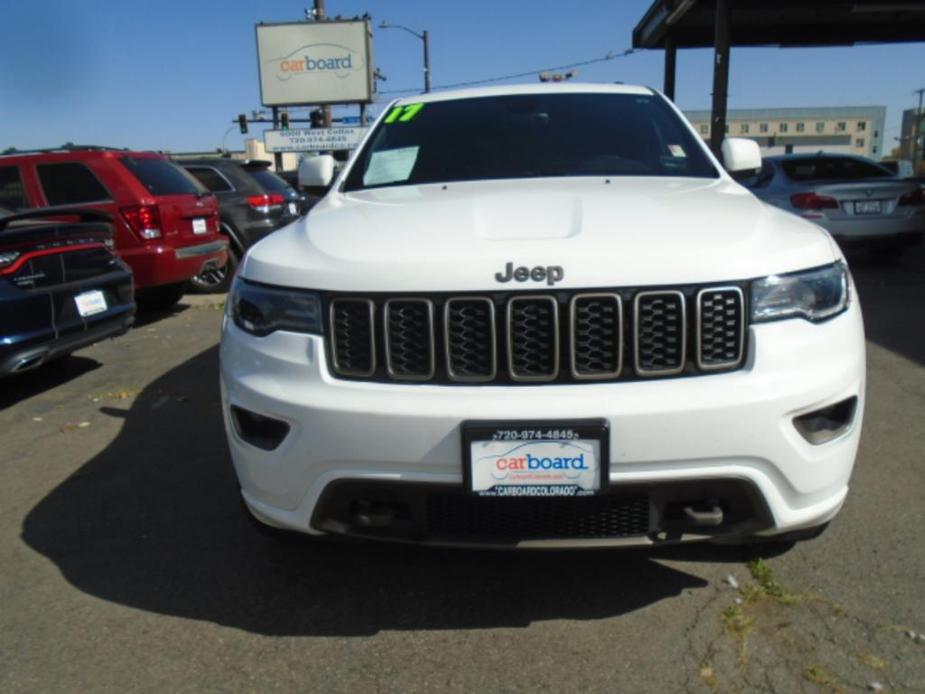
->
[0,145,304,377]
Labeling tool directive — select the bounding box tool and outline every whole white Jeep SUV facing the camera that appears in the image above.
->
[221,84,865,547]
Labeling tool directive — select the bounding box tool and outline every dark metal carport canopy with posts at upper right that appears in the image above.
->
[633,0,925,151]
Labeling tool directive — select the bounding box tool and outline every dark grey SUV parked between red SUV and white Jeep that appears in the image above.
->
[178,157,301,293]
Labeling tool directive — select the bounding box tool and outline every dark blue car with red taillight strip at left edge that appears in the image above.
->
[0,208,135,377]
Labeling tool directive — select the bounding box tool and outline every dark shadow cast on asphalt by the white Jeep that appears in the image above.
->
[22,348,756,636]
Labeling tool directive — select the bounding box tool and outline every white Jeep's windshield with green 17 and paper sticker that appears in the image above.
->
[345,93,717,190]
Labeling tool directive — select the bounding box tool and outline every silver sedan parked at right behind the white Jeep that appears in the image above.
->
[742,152,925,259]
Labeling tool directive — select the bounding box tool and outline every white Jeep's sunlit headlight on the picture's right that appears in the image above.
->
[752,262,848,322]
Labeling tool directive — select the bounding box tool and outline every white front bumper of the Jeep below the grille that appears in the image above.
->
[221,300,865,546]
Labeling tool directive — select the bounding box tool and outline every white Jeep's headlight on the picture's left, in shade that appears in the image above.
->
[229,278,322,337]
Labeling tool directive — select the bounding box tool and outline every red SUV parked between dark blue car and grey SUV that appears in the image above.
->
[0,147,228,307]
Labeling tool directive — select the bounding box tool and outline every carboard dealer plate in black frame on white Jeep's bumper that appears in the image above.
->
[462,419,610,497]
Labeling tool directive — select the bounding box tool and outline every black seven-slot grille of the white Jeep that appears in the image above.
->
[328,286,746,384]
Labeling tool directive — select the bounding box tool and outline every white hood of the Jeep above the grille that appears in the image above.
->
[241,178,838,291]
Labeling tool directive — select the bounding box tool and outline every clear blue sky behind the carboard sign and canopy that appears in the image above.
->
[0,0,925,151]
